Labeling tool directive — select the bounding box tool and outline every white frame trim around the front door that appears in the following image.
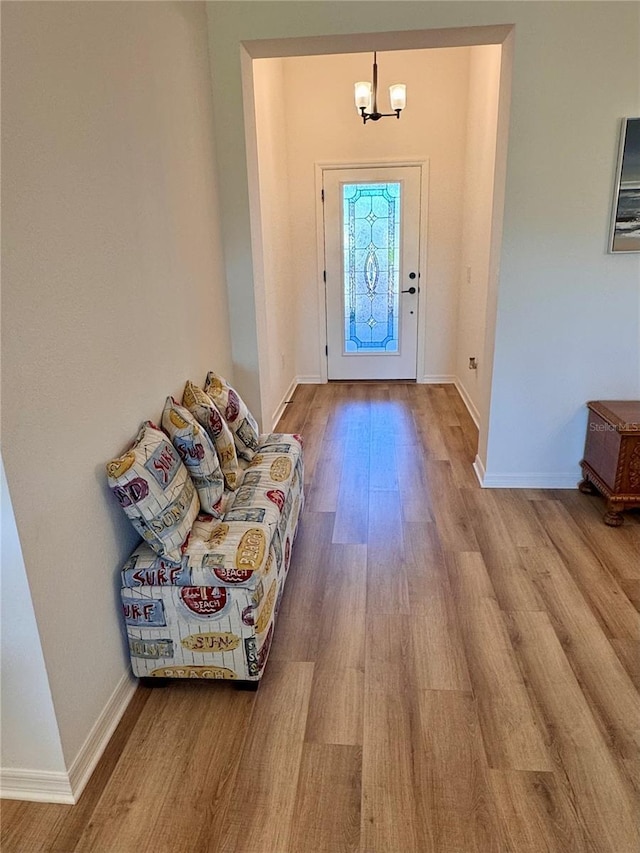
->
[314,157,429,383]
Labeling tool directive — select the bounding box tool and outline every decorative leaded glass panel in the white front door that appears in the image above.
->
[342,182,400,355]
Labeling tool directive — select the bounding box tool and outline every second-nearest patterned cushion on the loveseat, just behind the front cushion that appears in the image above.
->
[162,397,224,518]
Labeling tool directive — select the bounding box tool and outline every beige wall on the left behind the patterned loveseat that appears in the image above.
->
[2,2,232,780]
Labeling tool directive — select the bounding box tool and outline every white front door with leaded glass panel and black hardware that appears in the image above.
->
[323,166,421,379]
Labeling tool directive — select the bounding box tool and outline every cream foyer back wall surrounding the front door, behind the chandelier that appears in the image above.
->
[278,48,469,378]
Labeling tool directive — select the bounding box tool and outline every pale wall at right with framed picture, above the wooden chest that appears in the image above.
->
[487,2,640,487]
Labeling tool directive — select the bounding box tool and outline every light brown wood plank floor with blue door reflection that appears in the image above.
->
[1,383,640,853]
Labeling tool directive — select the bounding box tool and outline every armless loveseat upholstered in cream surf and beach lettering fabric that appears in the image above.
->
[108,372,304,686]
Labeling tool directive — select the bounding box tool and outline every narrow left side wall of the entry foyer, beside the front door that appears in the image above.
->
[253,59,299,430]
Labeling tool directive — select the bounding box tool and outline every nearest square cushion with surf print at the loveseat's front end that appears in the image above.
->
[107,421,200,562]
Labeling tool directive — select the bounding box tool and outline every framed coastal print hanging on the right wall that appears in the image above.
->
[610,118,640,252]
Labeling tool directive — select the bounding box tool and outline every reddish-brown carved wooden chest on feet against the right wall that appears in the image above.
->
[578,400,640,527]
